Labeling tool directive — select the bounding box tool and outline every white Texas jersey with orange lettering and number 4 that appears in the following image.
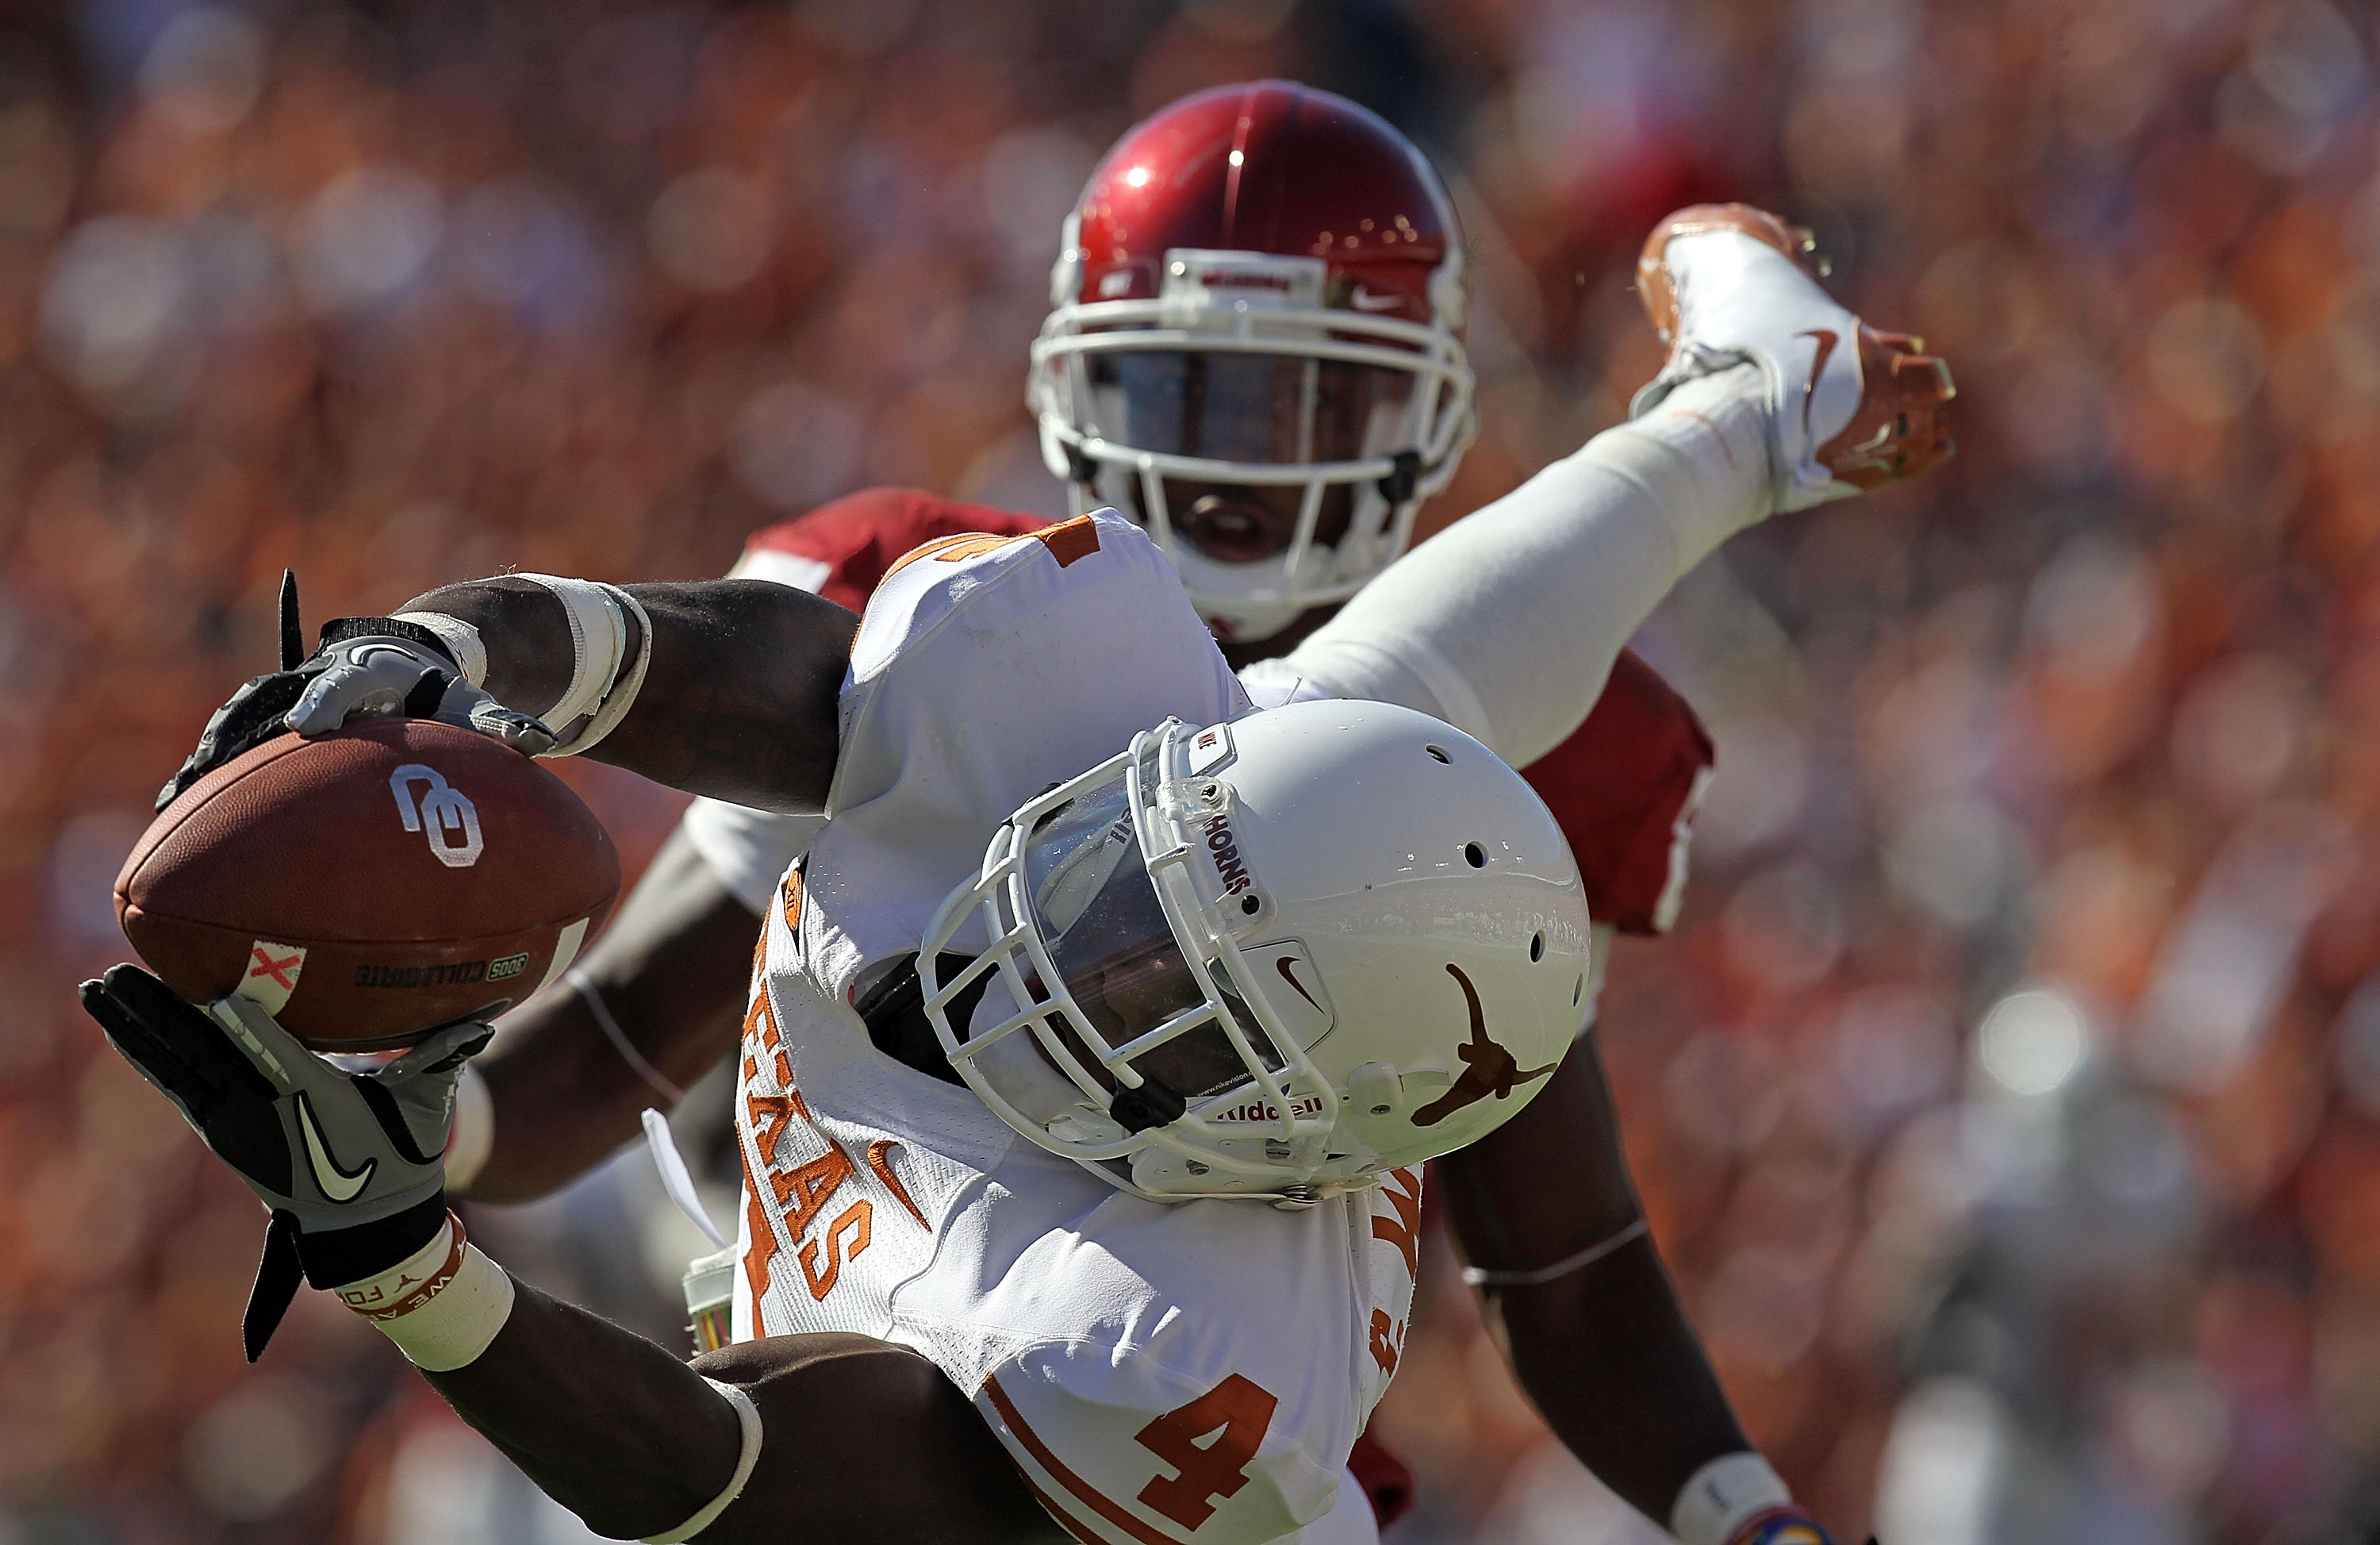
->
[735,512,1421,1545]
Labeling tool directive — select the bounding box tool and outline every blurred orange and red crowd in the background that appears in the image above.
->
[0,0,2380,1545]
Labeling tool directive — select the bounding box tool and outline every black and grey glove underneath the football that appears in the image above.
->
[81,967,493,1362]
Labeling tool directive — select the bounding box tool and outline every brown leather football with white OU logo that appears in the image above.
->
[117,719,619,1052]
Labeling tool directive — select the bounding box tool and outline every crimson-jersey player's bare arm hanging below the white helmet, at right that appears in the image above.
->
[1438,1036,1752,1526]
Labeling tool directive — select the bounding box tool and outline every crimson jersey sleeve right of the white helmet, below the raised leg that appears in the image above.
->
[1521,650,1714,933]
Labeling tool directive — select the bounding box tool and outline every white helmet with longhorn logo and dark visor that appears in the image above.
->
[919,700,1587,1202]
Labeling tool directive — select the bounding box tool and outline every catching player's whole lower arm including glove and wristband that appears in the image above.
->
[81,967,1061,1545]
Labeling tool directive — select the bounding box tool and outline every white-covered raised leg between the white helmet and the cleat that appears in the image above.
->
[1285,364,1773,767]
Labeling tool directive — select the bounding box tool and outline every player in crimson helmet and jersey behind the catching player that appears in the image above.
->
[400,83,1942,1524]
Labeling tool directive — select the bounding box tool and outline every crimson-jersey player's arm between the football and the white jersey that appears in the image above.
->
[469,828,759,1202]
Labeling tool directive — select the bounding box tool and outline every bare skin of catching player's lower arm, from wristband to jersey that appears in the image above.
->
[426,1281,1066,1545]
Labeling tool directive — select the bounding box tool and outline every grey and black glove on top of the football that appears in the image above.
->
[157,576,555,809]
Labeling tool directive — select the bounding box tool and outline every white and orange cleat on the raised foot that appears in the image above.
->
[1630,205,1959,509]
